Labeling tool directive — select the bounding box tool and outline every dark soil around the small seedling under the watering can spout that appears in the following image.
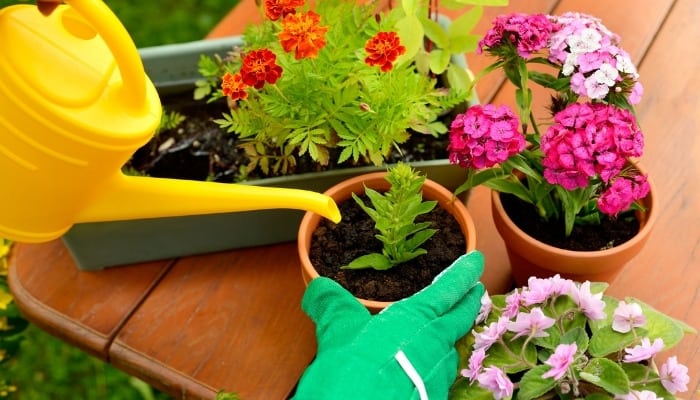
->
[309,198,466,301]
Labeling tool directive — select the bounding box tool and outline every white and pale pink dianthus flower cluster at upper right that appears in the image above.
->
[549,12,643,104]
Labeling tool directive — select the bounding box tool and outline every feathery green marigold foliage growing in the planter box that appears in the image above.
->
[200,0,468,174]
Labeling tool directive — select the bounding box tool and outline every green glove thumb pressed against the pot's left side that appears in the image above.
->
[301,277,370,351]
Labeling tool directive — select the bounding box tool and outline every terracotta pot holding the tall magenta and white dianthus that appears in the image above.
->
[491,165,658,286]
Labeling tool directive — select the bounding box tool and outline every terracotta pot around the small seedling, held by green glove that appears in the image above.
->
[297,172,476,313]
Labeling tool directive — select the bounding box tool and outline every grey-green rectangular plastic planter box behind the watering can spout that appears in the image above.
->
[62,36,476,270]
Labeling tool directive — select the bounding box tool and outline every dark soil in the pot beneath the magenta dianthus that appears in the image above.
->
[501,194,639,251]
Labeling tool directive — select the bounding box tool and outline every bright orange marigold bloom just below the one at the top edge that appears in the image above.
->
[279,11,328,60]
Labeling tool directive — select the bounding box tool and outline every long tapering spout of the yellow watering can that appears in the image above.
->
[76,173,340,228]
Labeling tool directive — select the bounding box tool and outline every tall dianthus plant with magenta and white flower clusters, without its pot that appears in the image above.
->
[448,13,649,236]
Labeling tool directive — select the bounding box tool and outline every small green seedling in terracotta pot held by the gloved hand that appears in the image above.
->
[297,163,476,313]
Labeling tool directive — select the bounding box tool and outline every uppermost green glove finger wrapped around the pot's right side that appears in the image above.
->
[392,251,484,319]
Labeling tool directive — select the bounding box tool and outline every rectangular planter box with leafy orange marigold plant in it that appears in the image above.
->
[58,0,504,269]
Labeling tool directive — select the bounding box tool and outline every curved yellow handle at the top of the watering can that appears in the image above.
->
[66,0,147,110]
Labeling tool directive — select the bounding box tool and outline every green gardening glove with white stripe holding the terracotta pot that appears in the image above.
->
[294,251,484,400]
